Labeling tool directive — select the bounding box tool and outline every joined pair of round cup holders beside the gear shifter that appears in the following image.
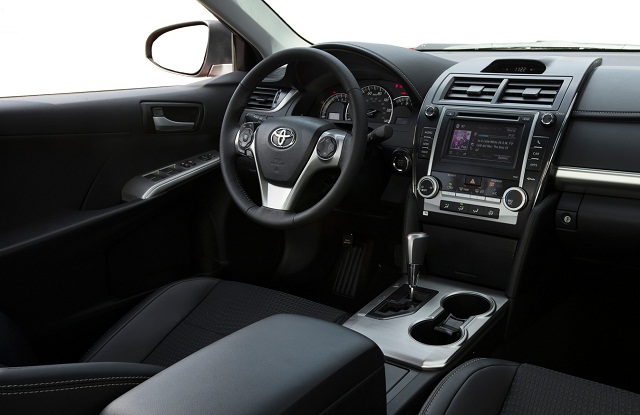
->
[410,293,492,346]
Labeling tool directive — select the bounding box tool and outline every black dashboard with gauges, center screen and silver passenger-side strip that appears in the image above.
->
[245,43,640,289]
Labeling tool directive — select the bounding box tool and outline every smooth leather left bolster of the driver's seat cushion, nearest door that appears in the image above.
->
[82,278,220,362]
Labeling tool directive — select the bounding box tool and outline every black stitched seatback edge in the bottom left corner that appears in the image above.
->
[0,363,163,415]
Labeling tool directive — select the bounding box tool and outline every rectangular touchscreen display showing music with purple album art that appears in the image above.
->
[443,120,523,168]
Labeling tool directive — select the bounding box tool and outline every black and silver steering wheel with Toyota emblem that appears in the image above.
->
[220,48,368,229]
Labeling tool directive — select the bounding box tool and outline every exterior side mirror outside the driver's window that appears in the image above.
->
[145,21,233,76]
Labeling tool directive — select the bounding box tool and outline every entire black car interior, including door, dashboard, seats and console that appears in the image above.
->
[0,1,640,415]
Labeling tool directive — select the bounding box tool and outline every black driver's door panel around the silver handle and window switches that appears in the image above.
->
[0,74,241,362]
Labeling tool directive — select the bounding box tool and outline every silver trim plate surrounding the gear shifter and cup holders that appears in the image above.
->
[344,276,508,370]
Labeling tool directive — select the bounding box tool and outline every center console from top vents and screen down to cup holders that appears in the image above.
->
[345,55,600,413]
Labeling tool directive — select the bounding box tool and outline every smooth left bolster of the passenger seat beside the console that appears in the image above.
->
[420,359,520,415]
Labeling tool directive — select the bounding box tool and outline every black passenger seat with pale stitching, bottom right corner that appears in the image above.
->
[420,359,640,415]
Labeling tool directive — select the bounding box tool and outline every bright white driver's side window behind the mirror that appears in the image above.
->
[0,0,215,97]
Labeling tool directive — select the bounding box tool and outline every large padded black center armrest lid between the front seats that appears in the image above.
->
[102,315,386,415]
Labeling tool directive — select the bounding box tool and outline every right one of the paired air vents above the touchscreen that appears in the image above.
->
[498,79,562,106]
